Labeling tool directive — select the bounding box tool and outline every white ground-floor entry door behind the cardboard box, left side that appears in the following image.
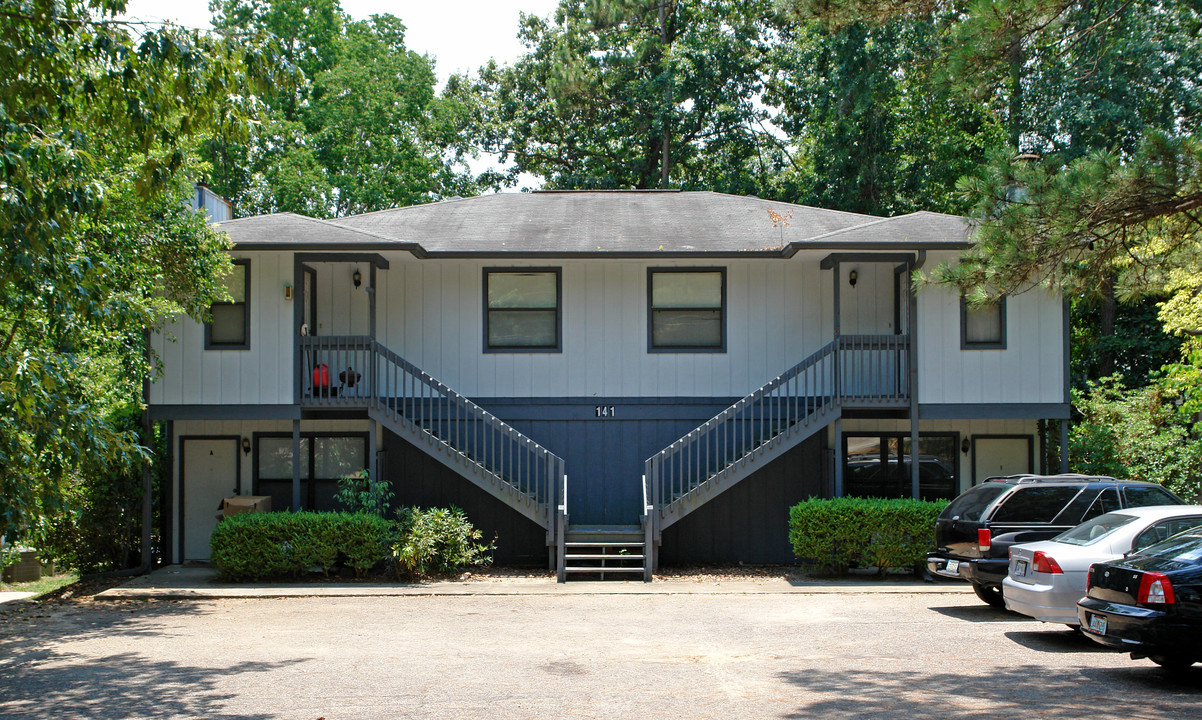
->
[183,438,238,560]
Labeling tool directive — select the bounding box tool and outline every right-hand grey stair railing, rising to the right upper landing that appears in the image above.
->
[644,335,910,537]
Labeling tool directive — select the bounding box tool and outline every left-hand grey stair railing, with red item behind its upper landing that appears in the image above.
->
[299,335,567,531]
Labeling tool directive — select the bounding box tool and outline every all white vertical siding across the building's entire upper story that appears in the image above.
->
[151,246,1064,405]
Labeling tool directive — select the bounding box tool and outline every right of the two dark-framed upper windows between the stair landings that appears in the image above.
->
[647,268,726,352]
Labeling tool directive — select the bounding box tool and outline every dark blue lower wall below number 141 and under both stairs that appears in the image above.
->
[383,398,828,565]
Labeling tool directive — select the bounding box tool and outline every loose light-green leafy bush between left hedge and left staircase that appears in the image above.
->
[392,507,496,577]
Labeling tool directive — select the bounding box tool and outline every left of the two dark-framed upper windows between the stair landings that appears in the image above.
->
[484,268,563,352]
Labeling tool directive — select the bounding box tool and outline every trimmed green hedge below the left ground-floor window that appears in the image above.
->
[209,512,393,581]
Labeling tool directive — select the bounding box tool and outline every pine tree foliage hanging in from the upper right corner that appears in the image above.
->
[785,0,1202,353]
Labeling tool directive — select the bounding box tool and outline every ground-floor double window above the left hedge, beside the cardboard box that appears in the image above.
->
[255,433,368,510]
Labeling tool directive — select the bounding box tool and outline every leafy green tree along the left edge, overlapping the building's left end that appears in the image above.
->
[0,0,267,540]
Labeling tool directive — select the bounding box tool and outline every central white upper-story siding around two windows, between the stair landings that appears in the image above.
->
[377,254,836,398]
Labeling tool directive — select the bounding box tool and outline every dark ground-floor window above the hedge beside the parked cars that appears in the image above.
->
[843,433,960,500]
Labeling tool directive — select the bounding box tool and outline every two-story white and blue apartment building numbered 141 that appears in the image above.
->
[150,191,1069,577]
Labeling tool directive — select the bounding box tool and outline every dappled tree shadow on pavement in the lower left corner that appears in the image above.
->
[0,602,298,720]
